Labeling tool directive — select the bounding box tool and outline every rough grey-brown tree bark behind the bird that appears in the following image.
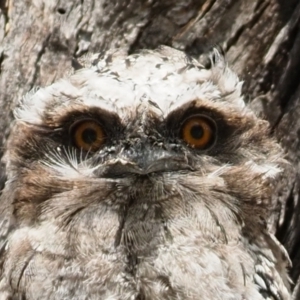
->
[0,0,300,297]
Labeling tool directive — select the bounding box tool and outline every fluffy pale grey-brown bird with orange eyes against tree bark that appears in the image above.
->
[0,46,291,300]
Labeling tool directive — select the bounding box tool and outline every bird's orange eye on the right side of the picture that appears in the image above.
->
[181,115,216,149]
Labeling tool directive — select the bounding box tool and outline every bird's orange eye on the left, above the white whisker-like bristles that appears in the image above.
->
[72,120,105,151]
